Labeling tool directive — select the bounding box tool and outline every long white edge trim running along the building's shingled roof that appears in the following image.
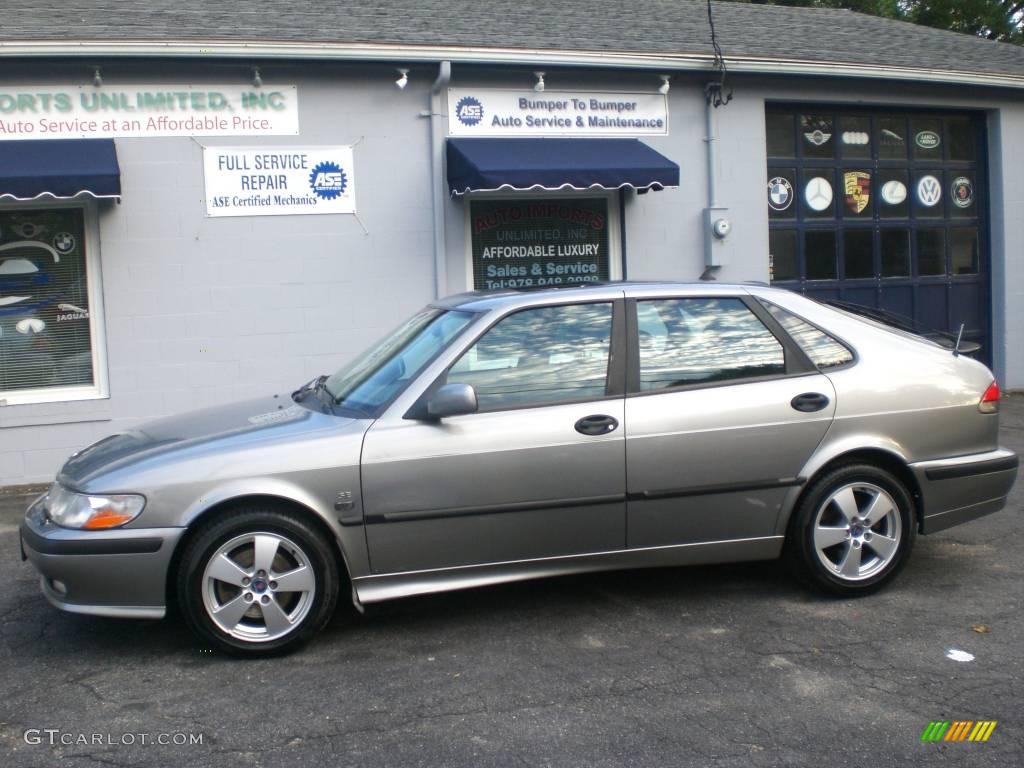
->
[0,40,1024,89]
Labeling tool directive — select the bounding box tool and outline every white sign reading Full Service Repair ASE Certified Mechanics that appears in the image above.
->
[203,145,355,216]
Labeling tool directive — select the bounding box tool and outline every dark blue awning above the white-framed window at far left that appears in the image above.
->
[0,138,121,200]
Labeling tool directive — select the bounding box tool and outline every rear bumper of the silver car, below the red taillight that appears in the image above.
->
[910,449,1019,534]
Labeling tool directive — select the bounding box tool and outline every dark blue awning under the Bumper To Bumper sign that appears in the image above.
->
[447,138,679,195]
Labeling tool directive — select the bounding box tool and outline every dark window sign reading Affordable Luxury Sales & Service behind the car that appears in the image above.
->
[470,198,609,291]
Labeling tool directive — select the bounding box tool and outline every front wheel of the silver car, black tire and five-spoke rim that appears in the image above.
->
[177,506,339,657]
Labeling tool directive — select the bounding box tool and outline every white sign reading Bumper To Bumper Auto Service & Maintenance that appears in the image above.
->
[449,88,669,136]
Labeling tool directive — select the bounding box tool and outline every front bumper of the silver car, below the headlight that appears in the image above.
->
[19,498,185,618]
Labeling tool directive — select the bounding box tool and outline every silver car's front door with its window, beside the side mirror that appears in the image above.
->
[362,300,626,573]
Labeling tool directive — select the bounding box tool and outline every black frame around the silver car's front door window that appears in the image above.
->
[419,298,627,419]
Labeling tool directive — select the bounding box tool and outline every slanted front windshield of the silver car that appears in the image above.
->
[325,308,474,416]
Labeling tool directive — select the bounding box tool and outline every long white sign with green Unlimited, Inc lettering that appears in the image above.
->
[0,84,299,141]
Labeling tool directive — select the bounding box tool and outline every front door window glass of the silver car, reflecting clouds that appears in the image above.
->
[447,303,611,411]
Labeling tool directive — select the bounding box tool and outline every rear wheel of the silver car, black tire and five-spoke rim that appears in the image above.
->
[784,464,918,597]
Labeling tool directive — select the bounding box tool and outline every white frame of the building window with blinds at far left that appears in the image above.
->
[0,199,111,408]
